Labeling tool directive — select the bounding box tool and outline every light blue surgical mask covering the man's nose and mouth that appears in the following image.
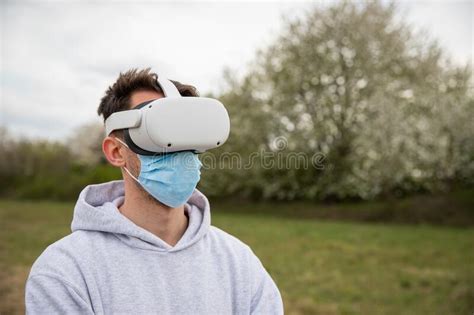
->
[117,138,202,208]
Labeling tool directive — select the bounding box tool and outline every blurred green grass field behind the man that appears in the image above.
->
[0,201,474,315]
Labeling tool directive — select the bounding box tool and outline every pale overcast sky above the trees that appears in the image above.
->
[0,0,474,139]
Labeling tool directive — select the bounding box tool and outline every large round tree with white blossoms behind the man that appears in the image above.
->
[205,1,474,199]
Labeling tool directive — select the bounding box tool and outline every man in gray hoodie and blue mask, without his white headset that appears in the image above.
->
[25,69,283,314]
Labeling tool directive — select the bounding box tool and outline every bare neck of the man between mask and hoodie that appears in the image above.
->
[119,181,188,246]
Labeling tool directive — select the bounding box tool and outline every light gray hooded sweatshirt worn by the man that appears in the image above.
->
[25,181,283,314]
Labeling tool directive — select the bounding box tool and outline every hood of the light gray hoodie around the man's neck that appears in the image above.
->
[71,180,211,252]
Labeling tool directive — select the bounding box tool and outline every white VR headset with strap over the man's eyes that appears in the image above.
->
[105,78,230,155]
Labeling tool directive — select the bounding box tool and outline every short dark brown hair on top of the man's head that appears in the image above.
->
[97,68,199,121]
